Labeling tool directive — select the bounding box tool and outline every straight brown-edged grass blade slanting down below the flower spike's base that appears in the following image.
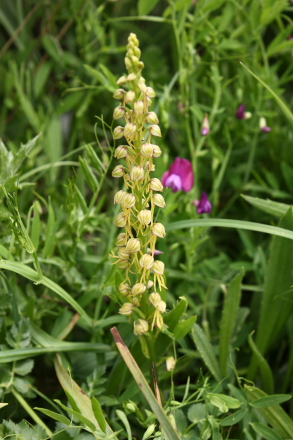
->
[111,327,180,440]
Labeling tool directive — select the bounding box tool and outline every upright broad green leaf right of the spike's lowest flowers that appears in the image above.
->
[219,270,244,376]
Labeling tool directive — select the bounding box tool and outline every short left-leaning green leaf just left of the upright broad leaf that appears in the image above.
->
[191,324,221,382]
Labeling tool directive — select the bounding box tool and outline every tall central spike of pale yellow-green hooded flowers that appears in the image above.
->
[112,33,166,335]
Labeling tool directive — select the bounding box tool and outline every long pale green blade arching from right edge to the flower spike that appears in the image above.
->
[166,218,293,240]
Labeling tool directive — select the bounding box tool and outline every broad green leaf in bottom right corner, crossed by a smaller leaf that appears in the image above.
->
[244,385,293,438]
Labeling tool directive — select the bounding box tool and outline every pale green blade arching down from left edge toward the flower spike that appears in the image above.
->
[0,260,92,324]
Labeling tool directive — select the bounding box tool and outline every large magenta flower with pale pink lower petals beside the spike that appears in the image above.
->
[162,157,194,192]
